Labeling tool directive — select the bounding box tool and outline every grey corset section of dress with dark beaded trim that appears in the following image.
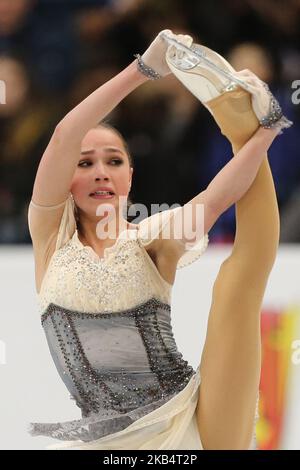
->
[31,298,195,441]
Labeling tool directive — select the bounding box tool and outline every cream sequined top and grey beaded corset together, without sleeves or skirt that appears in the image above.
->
[28,226,194,440]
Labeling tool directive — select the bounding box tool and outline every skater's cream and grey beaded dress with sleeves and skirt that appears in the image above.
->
[28,195,255,450]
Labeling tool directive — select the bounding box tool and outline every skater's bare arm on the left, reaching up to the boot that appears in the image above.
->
[32,31,190,206]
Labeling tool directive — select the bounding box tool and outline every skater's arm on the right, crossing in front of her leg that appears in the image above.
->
[171,70,292,245]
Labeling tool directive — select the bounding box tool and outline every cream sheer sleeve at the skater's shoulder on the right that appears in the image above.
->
[139,206,209,269]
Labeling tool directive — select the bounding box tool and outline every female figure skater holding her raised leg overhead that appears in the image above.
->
[28,30,289,450]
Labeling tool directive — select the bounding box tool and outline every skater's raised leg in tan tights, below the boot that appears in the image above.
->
[197,86,279,449]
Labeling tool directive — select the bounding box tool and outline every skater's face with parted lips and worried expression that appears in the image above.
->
[71,128,133,217]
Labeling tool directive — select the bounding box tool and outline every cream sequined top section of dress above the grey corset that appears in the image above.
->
[38,230,172,314]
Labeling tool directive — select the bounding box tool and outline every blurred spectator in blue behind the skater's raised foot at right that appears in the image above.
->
[199,43,300,242]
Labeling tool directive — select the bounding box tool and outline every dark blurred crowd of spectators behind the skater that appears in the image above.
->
[0,0,300,243]
